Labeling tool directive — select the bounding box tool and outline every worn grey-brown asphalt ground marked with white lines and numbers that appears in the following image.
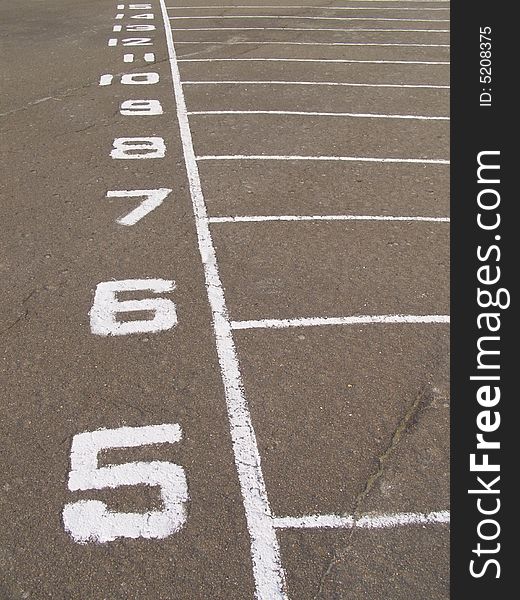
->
[0,0,449,600]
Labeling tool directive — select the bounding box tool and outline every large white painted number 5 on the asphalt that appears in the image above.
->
[63,424,189,543]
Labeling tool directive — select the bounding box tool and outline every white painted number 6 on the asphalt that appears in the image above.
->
[89,279,177,336]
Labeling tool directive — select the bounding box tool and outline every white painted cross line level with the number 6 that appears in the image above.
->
[231,315,450,329]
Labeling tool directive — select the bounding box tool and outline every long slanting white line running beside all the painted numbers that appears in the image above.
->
[159,0,287,600]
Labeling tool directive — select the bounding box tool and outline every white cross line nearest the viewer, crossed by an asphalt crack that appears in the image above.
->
[274,510,450,529]
